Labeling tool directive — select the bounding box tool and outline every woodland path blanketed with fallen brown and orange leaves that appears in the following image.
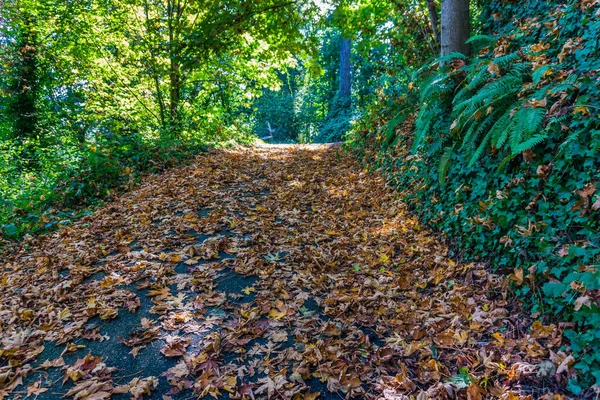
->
[0,146,573,400]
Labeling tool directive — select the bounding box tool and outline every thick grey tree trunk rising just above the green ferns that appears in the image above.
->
[441,0,471,56]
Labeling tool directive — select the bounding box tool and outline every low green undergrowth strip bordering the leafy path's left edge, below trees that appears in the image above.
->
[0,134,253,246]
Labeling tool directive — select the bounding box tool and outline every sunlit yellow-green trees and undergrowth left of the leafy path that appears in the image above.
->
[0,0,317,242]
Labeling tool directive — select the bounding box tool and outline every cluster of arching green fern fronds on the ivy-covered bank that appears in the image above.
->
[412,41,576,184]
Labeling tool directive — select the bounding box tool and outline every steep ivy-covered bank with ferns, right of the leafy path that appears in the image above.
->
[350,0,600,396]
